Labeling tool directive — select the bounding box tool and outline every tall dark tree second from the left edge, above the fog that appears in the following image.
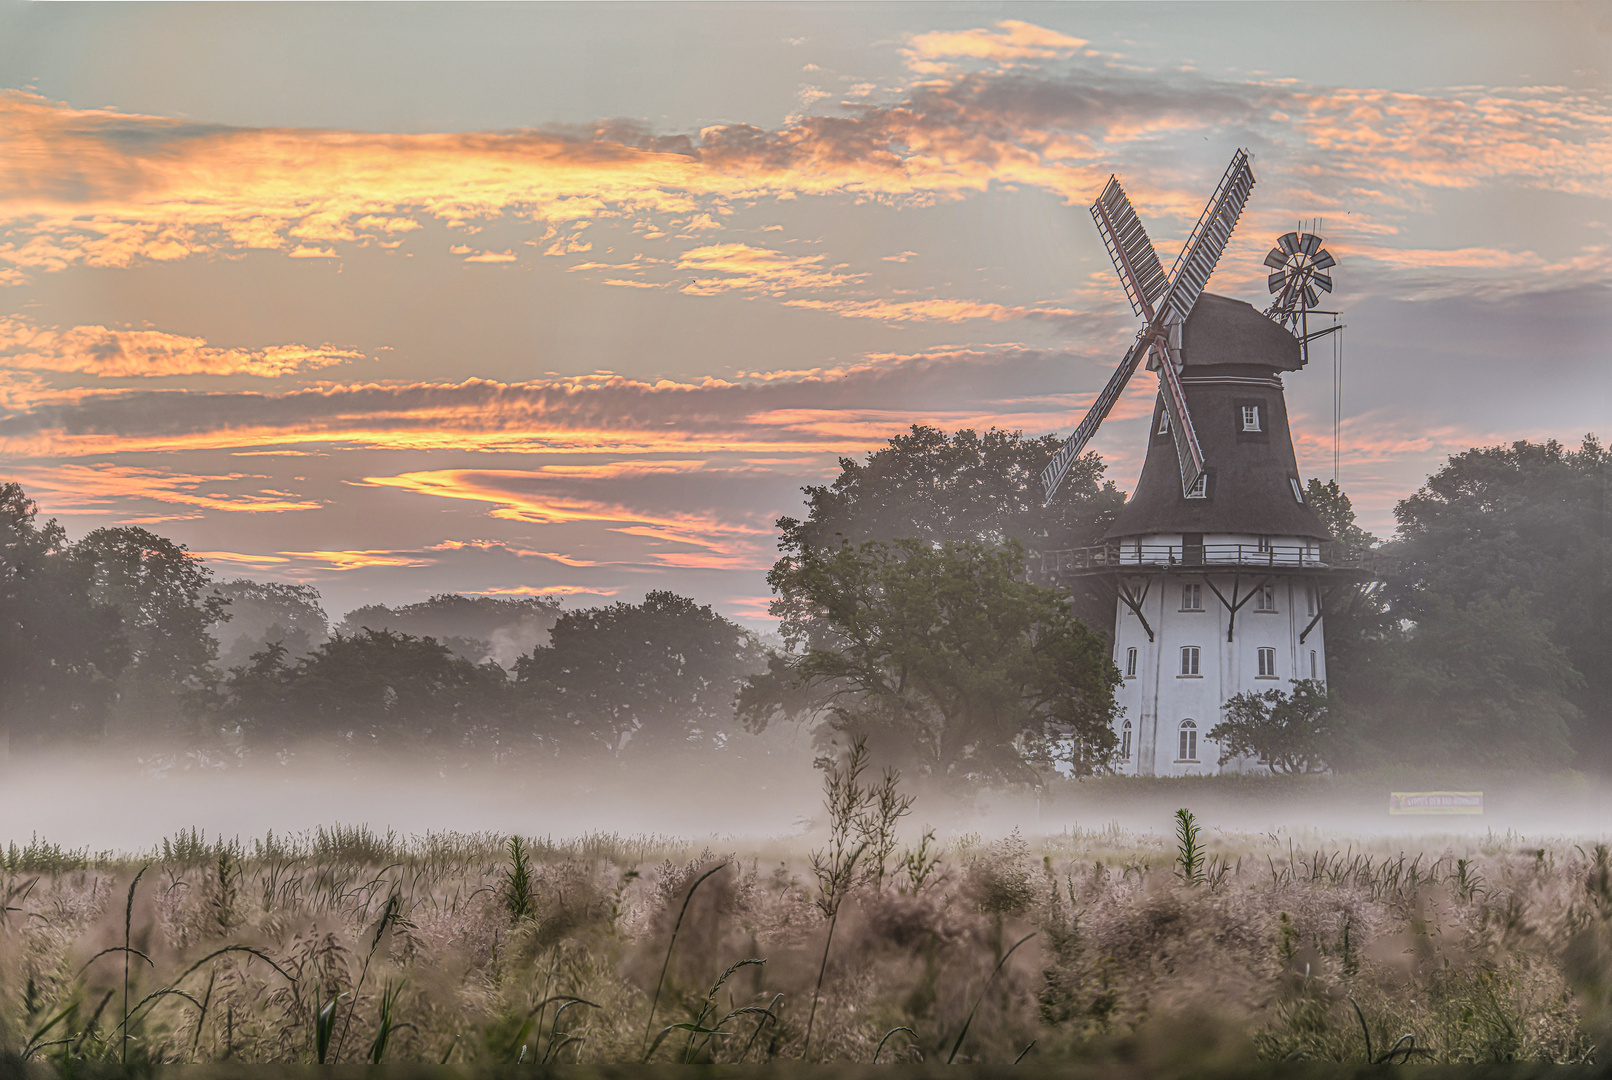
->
[73,527,227,741]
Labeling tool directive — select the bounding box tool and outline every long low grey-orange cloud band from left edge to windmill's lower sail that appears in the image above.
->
[0,348,1119,467]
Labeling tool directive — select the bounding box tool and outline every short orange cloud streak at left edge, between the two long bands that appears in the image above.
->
[0,316,364,379]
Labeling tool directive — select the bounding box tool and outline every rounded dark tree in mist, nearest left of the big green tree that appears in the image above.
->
[516,590,762,754]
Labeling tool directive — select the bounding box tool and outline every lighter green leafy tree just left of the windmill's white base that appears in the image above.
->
[740,538,1120,780]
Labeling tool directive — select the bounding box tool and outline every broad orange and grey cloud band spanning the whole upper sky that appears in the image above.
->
[0,69,1612,292]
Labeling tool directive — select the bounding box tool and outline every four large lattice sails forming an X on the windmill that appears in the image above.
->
[1041,150,1254,503]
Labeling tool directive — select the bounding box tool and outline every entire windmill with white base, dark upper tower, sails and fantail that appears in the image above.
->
[1041,150,1336,775]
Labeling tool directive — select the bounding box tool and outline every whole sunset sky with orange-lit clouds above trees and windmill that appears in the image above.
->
[0,0,1612,629]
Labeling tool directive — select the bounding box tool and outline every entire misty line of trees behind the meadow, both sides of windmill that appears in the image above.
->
[0,427,1612,780]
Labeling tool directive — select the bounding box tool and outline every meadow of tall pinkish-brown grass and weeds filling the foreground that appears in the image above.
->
[0,802,1612,1069]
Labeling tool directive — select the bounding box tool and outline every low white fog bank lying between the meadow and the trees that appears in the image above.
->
[0,744,1612,853]
